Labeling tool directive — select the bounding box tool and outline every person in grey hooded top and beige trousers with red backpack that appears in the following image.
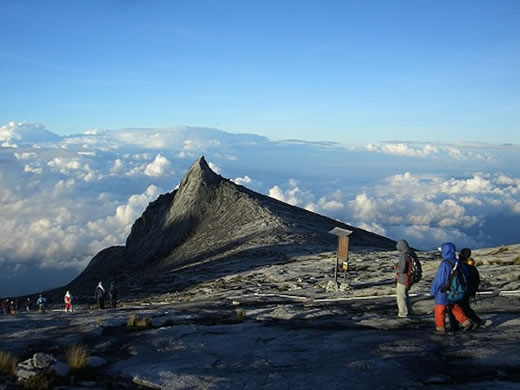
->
[394,240,422,318]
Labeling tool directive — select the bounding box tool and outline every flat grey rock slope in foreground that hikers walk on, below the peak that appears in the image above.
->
[4,245,520,390]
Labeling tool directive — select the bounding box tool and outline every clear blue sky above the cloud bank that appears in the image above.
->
[0,0,520,144]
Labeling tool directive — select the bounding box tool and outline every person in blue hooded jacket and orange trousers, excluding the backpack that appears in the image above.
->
[430,242,474,334]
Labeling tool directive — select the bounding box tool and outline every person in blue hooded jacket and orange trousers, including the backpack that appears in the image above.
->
[430,242,474,334]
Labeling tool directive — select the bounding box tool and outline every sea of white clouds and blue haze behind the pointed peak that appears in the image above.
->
[0,122,520,296]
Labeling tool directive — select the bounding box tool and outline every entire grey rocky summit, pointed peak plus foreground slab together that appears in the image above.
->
[5,158,520,390]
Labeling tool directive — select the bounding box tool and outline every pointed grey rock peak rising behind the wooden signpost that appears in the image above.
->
[66,157,395,296]
